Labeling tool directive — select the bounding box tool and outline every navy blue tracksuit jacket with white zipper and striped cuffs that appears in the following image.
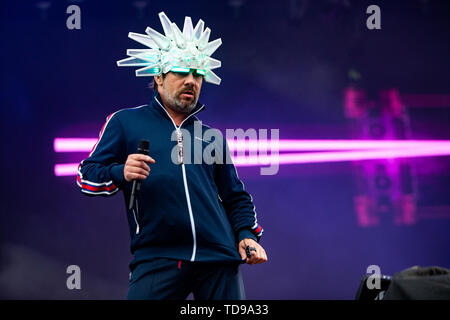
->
[77,92,263,269]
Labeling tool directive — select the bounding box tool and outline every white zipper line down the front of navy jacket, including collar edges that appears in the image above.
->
[155,98,205,261]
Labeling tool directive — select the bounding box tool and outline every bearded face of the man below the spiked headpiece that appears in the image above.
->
[155,69,203,114]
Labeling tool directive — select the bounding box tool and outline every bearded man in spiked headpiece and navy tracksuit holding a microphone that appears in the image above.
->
[77,12,267,299]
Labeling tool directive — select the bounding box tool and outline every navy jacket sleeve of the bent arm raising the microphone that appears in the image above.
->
[77,113,126,196]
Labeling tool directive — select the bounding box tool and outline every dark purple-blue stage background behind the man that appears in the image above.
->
[0,0,450,299]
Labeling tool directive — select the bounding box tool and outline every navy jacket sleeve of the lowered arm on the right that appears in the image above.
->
[214,135,263,243]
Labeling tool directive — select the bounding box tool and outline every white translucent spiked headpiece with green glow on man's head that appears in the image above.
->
[117,12,222,85]
